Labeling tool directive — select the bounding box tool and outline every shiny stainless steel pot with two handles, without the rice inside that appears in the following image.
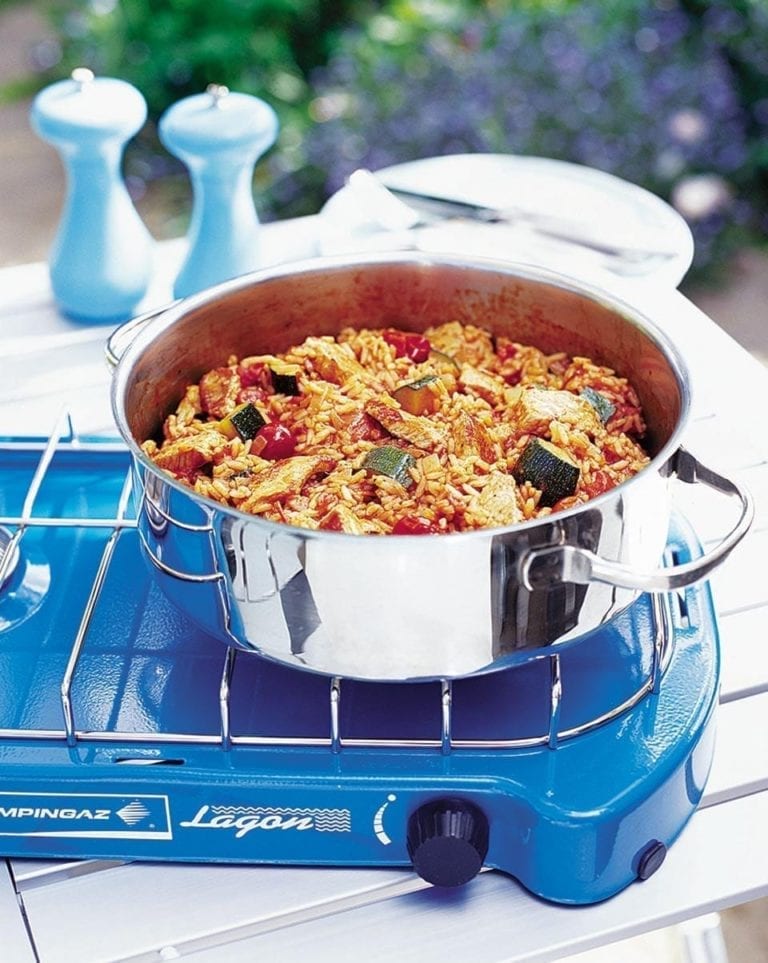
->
[108,254,753,680]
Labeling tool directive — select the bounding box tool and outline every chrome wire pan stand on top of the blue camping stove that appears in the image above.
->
[0,410,673,754]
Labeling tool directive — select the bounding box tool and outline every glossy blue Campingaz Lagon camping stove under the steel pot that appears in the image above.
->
[0,437,719,903]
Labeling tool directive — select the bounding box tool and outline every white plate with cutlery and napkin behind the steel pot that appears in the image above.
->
[319,154,694,287]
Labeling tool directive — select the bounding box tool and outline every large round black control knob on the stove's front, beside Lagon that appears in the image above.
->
[406,799,488,886]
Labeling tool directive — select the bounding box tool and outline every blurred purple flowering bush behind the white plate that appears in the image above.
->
[304,0,756,274]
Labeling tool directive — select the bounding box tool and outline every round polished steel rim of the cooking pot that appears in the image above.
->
[110,251,691,542]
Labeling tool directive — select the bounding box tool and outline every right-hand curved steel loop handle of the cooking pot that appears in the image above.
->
[520,448,755,592]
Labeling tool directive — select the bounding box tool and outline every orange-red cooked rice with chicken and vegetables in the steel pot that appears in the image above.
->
[142,321,649,534]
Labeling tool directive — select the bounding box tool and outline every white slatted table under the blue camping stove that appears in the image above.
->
[0,218,768,963]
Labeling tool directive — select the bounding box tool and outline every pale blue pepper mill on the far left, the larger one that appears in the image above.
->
[31,67,153,323]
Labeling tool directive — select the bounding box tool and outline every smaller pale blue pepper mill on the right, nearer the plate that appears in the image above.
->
[158,84,278,297]
